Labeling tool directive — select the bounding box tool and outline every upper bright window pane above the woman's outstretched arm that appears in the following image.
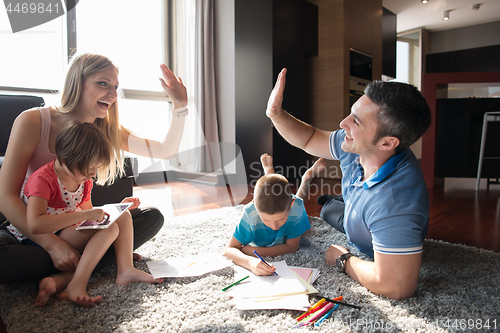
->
[76,0,166,96]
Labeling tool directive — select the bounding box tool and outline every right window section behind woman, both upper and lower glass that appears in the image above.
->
[76,0,177,172]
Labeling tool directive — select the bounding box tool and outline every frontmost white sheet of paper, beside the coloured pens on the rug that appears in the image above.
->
[233,295,311,311]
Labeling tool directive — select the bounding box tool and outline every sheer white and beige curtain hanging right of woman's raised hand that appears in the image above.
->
[176,0,221,172]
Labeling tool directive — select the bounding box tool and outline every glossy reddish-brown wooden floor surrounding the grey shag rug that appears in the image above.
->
[0,179,500,333]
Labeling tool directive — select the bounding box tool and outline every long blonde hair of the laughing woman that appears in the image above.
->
[57,53,125,185]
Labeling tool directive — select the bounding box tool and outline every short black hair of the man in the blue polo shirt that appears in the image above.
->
[365,81,431,153]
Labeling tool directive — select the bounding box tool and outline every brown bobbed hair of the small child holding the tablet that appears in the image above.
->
[55,122,111,177]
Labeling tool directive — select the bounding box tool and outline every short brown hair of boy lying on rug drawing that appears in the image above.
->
[253,174,292,215]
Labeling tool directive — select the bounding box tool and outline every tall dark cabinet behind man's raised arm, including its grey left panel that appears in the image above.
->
[235,0,318,183]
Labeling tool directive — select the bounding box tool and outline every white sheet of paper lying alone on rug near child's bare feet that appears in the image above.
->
[147,253,232,279]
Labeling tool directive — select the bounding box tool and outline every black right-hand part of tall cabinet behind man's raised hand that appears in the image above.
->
[272,0,318,179]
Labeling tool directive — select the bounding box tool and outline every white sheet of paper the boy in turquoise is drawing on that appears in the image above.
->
[228,260,307,298]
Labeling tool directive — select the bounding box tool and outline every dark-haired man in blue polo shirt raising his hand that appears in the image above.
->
[266,69,431,299]
